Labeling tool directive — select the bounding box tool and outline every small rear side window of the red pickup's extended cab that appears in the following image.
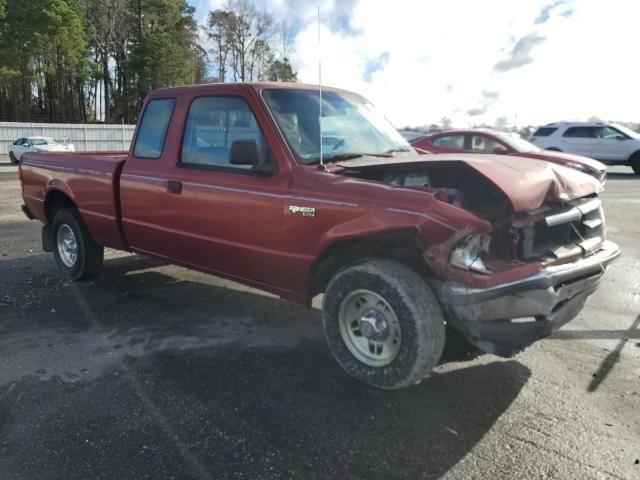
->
[133,98,176,159]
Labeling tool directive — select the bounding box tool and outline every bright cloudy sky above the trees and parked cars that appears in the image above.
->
[189,0,640,128]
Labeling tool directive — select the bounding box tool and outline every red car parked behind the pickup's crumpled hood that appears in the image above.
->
[411,129,607,183]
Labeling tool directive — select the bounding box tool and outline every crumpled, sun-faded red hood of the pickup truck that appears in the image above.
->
[328,153,602,212]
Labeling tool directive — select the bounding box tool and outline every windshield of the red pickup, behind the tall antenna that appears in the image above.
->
[262,89,414,164]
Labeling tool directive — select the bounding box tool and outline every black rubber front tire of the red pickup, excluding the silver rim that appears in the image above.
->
[322,259,445,390]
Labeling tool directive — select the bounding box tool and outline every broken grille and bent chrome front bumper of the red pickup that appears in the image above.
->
[434,197,620,356]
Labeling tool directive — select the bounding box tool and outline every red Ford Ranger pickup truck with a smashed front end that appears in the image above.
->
[20,83,620,389]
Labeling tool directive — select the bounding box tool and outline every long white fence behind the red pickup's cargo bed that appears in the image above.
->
[0,122,135,155]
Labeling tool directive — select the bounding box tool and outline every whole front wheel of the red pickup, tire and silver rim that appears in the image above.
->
[322,260,445,390]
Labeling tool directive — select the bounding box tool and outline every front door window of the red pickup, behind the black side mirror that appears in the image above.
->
[180,96,268,170]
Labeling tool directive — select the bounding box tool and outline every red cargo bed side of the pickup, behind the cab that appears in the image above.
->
[20,152,127,248]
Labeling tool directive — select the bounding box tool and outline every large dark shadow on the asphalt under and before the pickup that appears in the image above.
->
[0,256,531,479]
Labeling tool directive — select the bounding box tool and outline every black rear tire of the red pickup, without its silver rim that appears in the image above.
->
[51,208,104,280]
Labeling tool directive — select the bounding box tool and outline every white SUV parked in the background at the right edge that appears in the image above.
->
[529,122,640,175]
